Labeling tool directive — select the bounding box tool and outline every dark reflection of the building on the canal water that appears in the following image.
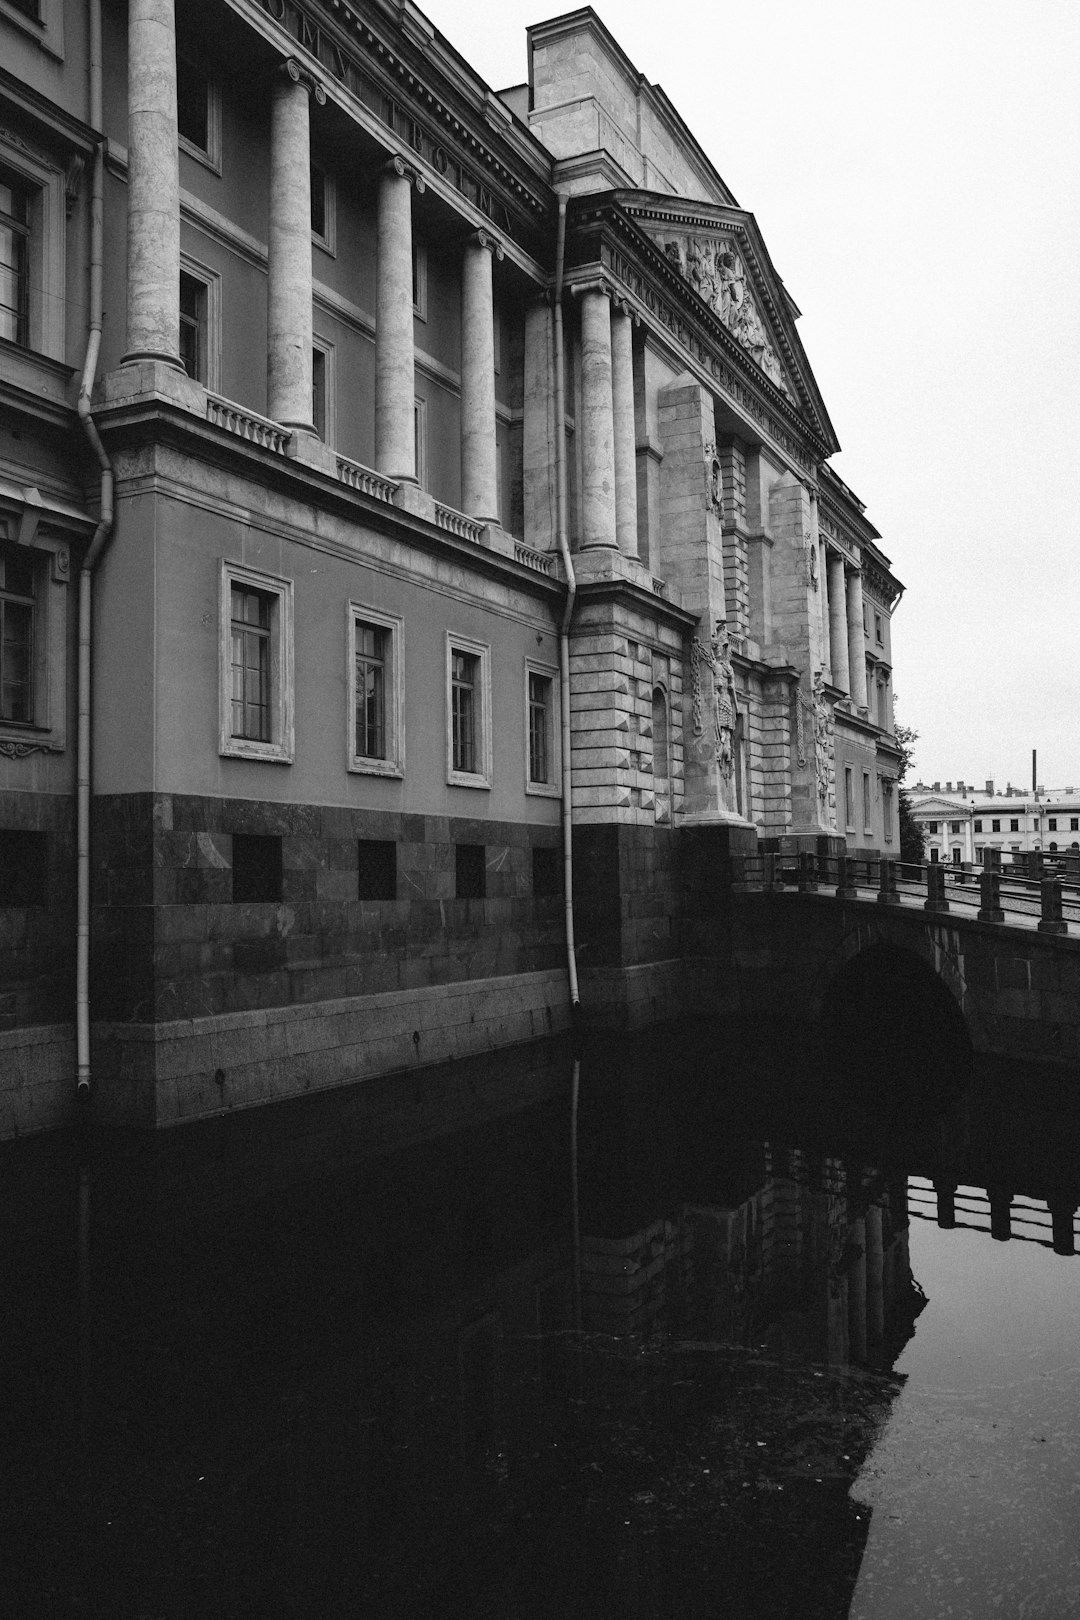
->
[0,1048,1061,1620]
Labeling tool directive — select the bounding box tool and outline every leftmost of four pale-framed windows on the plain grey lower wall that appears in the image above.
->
[219,562,293,765]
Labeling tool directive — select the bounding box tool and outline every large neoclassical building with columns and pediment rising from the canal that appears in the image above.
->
[0,0,900,1134]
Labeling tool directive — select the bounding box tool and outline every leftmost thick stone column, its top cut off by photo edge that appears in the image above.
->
[123,0,181,369]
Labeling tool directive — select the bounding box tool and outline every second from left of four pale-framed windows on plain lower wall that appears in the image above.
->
[348,603,405,776]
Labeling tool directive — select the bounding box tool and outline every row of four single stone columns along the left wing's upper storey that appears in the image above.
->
[123,0,508,511]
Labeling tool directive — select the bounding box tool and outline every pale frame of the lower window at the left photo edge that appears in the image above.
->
[0,507,71,758]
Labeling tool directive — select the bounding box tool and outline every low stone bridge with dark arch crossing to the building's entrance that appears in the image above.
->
[729,852,1080,1084]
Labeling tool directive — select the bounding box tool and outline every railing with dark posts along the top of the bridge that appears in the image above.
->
[732,851,1080,933]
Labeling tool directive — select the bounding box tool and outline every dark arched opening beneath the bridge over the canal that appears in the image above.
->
[811,925,978,1097]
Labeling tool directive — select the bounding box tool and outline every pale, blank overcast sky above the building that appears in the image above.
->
[421,0,1080,789]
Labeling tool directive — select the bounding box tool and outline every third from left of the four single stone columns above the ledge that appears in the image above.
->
[376,157,423,483]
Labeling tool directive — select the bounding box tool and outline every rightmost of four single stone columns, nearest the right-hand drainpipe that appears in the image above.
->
[461,230,502,523]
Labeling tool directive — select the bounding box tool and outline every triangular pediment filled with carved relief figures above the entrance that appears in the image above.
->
[619,191,839,447]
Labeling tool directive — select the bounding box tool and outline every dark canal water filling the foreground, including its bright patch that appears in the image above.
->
[0,1029,1080,1620]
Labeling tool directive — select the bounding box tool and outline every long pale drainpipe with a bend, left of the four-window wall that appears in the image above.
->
[74,0,113,1098]
